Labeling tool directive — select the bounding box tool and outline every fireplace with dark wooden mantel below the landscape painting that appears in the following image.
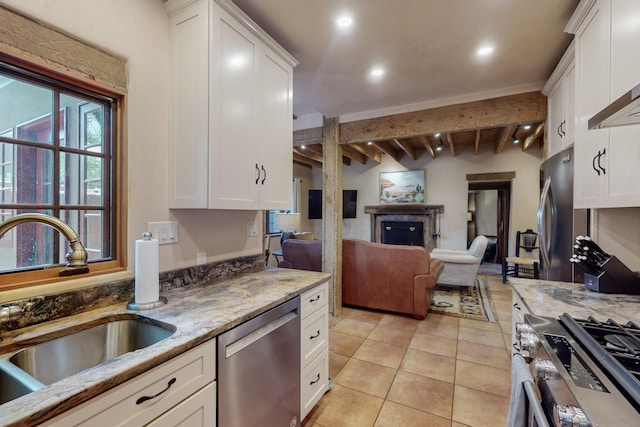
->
[364,204,444,251]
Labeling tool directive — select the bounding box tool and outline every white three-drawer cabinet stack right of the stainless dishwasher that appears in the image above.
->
[300,282,329,420]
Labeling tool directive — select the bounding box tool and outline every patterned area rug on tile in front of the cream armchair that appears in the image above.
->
[429,278,498,322]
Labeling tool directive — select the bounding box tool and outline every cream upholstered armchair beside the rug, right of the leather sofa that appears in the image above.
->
[431,236,488,286]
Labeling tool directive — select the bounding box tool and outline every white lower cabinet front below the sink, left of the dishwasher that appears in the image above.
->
[43,339,216,427]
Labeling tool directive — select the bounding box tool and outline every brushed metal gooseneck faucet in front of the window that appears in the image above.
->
[0,213,89,276]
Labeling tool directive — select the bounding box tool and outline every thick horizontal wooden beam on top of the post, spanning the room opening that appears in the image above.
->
[340,92,547,144]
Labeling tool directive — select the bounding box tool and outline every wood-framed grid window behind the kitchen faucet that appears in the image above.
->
[0,62,120,283]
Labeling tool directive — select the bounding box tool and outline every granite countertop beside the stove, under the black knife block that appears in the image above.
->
[509,278,640,324]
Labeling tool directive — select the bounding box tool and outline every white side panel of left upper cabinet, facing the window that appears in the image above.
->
[169,1,209,208]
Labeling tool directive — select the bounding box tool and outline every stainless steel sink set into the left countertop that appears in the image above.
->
[0,317,175,405]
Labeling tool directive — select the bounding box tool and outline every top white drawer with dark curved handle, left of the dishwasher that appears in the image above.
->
[45,339,216,427]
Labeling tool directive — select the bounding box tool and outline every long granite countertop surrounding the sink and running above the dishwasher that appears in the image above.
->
[0,268,331,426]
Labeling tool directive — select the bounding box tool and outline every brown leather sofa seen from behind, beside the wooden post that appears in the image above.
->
[342,239,443,319]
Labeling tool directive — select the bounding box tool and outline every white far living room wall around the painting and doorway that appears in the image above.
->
[336,141,542,254]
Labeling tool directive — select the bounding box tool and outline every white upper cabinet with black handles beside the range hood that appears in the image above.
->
[574,0,640,208]
